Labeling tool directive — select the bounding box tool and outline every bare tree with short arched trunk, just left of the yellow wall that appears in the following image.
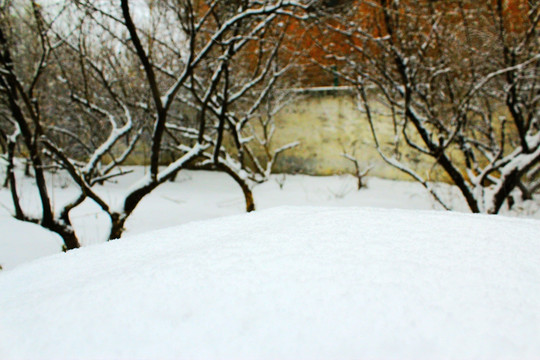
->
[168,7,298,211]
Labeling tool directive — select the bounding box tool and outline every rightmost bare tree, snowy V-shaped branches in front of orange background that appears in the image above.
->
[316,0,540,213]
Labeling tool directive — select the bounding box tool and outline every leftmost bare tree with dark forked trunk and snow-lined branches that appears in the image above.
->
[0,1,146,249]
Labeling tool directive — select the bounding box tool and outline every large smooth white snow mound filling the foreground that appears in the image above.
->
[0,207,540,359]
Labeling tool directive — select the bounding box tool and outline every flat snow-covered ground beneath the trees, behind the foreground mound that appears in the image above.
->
[0,167,540,270]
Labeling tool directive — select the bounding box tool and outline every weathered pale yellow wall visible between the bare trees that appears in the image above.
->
[273,91,437,180]
